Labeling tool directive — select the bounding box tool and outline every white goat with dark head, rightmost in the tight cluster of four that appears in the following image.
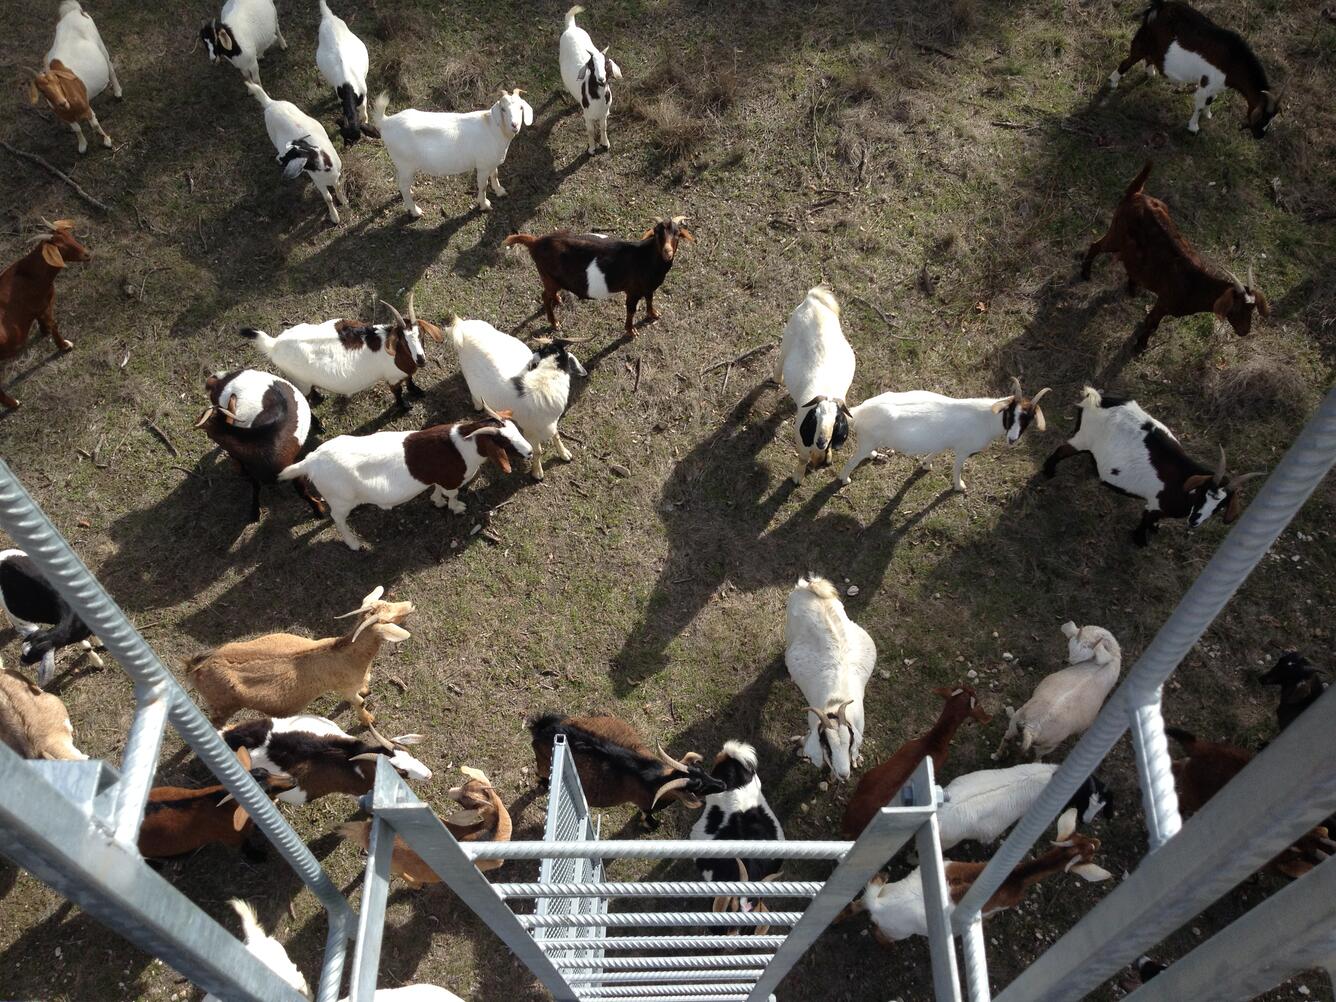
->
[450,317,588,480]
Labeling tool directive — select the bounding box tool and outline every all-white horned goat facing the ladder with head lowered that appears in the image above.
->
[784,576,876,782]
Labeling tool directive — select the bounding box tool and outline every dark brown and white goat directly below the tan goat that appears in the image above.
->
[218,716,432,804]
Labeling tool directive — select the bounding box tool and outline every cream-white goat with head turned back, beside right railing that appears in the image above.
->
[993,621,1122,760]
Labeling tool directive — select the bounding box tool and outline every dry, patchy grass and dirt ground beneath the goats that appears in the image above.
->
[0,0,1336,1002]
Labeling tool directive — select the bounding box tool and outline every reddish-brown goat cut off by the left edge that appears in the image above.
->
[0,219,92,410]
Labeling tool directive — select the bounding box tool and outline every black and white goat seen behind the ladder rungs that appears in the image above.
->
[691,741,784,935]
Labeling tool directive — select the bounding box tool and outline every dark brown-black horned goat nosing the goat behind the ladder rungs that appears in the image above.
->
[529,713,727,831]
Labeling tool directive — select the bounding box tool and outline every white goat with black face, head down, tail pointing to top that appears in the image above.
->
[774,286,854,484]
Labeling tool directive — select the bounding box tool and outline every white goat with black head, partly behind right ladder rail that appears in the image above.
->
[937,762,1113,850]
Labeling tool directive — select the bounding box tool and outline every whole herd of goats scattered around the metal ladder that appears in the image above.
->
[0,0,1333,999]
